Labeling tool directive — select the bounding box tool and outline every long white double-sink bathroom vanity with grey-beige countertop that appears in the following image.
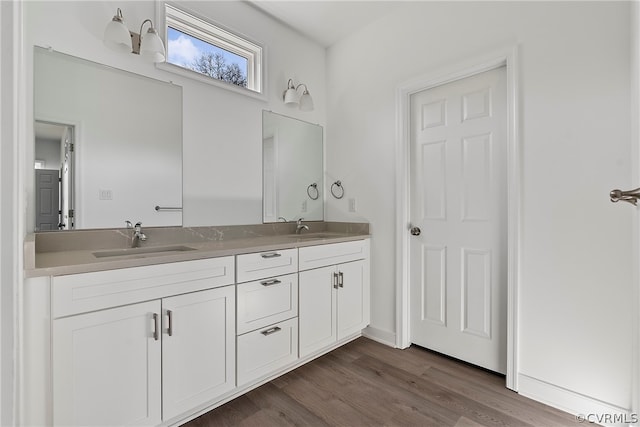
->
[22,223,370,425]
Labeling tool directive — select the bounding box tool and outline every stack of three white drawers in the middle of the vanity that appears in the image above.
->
[236,249,298,386]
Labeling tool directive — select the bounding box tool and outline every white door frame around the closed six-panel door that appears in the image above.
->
[396,45,522,391]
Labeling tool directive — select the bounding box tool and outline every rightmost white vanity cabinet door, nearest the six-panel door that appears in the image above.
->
[337,261,369,340]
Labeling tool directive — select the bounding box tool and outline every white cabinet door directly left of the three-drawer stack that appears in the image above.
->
[162,286,236,421]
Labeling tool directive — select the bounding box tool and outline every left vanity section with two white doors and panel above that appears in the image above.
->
[51,257,235,426]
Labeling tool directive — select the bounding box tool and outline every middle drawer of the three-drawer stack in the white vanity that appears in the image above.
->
[236,273,298,335]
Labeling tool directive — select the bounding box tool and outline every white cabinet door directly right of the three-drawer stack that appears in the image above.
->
[298,266,336,357]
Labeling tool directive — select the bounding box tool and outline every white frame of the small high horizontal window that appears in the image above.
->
[156,1,267,101]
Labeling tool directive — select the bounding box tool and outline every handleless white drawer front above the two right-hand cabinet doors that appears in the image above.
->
[299,239,369,271]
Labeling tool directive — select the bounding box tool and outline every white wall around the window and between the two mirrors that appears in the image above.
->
[25,0,325,229]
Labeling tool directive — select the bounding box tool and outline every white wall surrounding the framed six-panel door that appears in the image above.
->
[326,2,637,414]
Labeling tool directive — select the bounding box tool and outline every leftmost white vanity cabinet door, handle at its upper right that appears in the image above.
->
[52,300,161,426]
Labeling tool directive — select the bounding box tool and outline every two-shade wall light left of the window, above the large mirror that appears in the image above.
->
[103,8,165,62]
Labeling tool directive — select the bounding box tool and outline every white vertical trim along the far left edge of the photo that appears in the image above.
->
[0,2,27,425]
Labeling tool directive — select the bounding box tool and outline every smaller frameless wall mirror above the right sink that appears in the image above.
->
[262,111,324,223]
